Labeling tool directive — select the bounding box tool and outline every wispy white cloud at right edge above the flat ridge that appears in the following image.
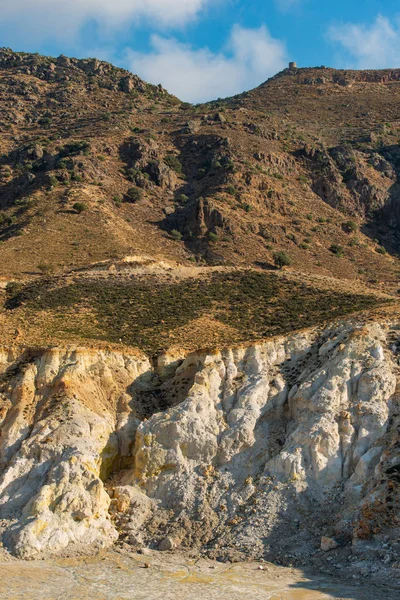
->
[328,15,400,69]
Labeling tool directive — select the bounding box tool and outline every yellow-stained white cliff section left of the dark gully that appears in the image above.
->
[0,349,149,557]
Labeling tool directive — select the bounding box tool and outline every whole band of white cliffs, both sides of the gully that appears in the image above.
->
[0,322,398,557]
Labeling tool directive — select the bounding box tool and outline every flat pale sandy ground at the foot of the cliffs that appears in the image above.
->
[0,552,400,600]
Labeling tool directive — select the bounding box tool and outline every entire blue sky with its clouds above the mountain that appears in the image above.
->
[0,0,400,102]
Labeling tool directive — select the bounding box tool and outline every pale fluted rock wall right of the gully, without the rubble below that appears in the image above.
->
[135,326,396,492]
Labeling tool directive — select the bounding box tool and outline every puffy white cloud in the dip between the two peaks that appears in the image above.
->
[127,25,288,102]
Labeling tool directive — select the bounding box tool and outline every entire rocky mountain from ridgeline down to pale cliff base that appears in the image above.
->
[0,49,400,578]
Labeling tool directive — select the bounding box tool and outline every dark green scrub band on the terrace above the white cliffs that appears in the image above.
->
[7,271,377,353]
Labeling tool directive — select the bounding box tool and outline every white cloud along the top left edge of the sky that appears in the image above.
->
[0,0,215,41]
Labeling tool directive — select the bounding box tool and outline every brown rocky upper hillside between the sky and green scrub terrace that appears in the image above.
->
[0,49,400,291]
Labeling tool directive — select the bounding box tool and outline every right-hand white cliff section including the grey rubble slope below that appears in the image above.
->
[130,324,397,551]
